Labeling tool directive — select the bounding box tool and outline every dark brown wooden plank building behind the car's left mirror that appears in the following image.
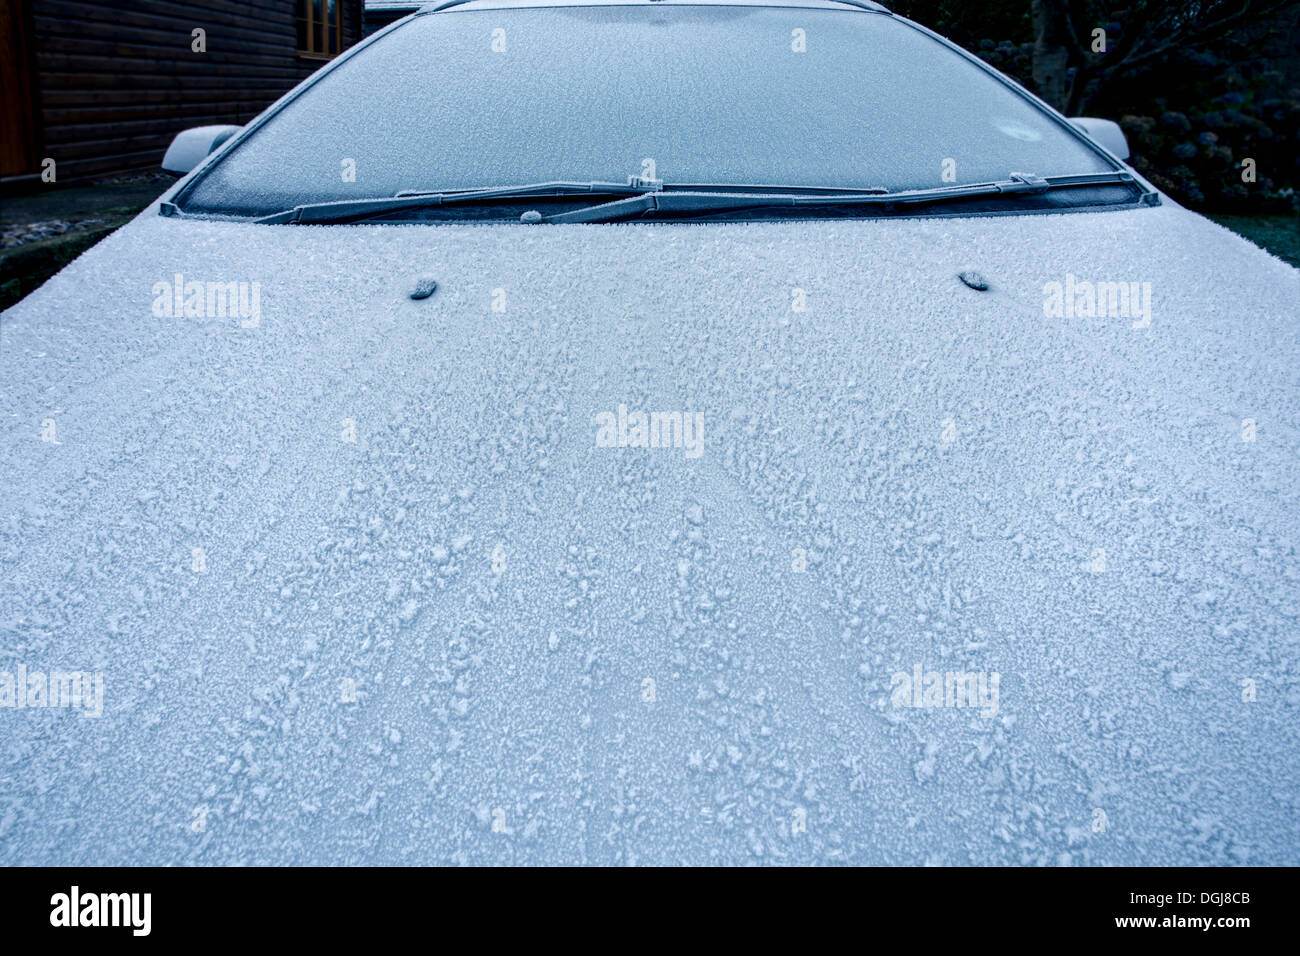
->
[0,0,363,187]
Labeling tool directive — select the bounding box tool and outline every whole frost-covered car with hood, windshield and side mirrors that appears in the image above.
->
[0,0,1300,865]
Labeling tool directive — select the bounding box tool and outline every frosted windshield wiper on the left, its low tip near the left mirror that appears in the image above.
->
[254,177,663,225]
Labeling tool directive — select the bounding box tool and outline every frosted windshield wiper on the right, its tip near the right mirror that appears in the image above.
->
[530,173,1154,222]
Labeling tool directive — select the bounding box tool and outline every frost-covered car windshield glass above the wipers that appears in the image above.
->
[179,4,1114,216]
